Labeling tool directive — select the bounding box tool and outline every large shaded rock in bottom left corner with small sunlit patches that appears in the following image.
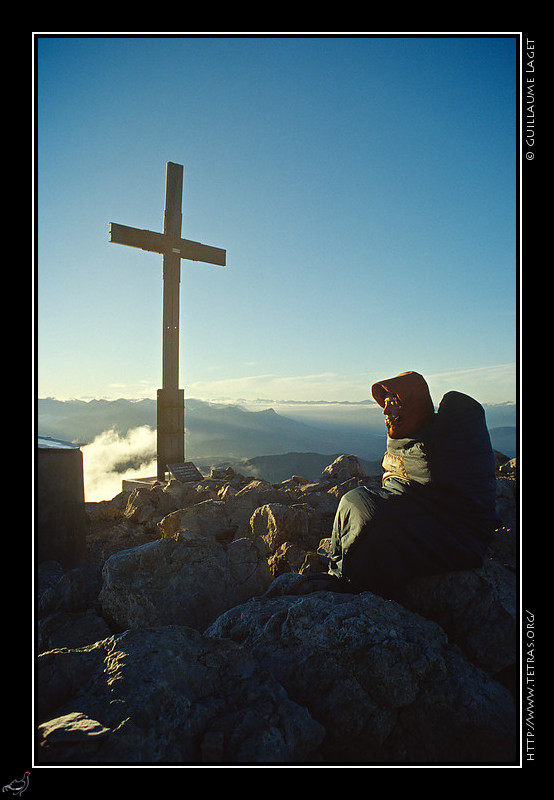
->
[37,626,324,764]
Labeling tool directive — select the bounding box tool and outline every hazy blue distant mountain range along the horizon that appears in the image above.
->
[36,398,516,468]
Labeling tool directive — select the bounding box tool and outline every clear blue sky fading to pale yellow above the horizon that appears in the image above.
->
[35,34,519,402]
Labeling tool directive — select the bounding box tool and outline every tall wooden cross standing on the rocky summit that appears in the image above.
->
[110,162,226,481]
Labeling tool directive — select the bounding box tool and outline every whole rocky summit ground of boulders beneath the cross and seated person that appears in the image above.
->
[36,454,518,766]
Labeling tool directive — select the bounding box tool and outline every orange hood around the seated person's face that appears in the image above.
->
[371,372,435,439]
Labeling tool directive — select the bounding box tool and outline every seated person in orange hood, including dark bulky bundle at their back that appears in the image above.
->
[316,372,499,599]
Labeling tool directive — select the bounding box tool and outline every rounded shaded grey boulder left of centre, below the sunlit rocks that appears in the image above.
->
[99,532,272,630]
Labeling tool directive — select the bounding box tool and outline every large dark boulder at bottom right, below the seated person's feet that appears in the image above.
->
[205,588,517,764]
